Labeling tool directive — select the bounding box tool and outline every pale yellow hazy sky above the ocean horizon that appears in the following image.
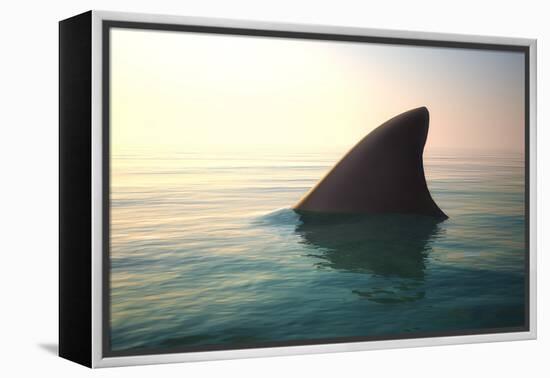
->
[110,28,525,155]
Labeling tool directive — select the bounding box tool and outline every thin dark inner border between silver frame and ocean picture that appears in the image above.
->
[101,20,531,357]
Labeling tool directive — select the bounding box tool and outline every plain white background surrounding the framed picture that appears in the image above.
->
[0,0,550,378]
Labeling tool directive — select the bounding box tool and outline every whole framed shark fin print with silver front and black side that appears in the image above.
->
[59,11,536,367]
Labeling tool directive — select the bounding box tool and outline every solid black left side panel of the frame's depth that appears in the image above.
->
[58,11,92,367]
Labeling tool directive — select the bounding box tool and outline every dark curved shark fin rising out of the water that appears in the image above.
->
[293,107,448,220]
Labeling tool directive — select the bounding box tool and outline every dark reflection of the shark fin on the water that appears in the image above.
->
[296,213,440,303]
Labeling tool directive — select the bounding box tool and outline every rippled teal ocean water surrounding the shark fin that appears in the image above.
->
[110,148,526,353]
